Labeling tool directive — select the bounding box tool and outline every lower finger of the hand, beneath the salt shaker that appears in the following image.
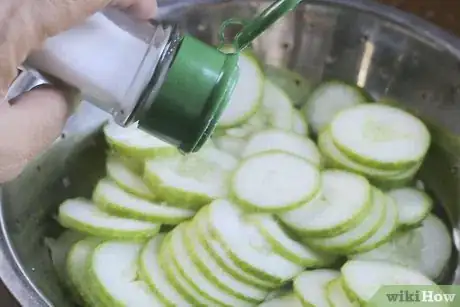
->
[0,86,69,183]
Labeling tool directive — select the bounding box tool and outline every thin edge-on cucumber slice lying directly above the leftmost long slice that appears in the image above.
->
[93,179,195,225]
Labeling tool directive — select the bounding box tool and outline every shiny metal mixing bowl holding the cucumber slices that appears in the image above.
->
[0,0,460,307]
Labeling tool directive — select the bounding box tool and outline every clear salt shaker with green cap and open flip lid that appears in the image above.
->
[26,0,300,153]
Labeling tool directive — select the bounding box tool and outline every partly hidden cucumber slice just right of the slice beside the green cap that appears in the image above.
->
[262,80,294,131]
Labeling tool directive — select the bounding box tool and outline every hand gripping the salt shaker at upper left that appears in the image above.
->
[0,0,157,184]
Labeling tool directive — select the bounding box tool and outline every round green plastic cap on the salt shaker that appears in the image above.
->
[140,35,239,153]
